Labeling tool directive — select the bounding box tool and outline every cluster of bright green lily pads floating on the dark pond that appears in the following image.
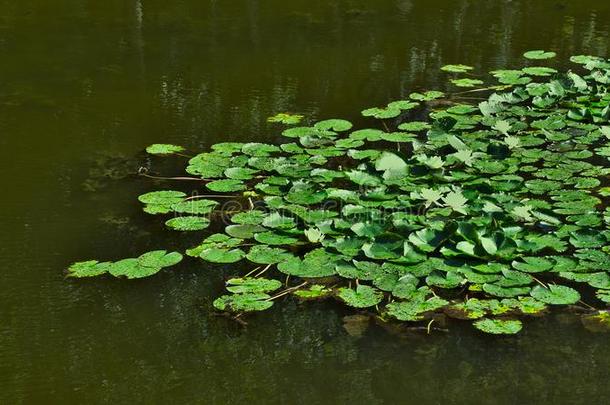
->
[69,51,610,334]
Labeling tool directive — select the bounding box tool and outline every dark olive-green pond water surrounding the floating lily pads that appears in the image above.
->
[0,0,610,404]
